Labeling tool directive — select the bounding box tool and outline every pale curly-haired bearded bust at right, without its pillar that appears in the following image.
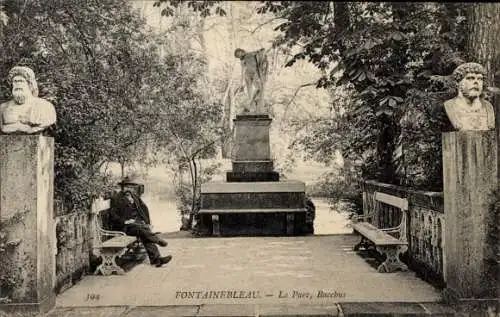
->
[444,63,495,131]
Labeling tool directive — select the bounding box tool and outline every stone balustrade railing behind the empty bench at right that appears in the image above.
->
[363,180,444,287]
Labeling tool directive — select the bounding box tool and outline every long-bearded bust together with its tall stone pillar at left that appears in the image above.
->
[0,67,56,315]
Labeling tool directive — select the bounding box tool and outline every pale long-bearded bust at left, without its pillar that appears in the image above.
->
[0,66,56,134]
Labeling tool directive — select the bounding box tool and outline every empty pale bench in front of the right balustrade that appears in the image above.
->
[352,192,408,273]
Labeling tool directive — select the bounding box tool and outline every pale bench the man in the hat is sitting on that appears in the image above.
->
[92,200,142,275]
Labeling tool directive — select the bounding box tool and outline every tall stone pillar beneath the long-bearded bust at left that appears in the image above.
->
[0,135,56,313]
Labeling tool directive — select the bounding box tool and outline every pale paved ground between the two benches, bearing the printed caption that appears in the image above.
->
[48,196,453,317]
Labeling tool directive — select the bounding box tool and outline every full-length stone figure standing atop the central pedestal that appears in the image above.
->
[234,48,269,114]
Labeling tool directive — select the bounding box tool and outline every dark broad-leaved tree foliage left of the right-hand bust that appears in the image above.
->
[259,1,465,189]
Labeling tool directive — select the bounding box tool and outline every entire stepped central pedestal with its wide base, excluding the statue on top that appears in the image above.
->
[199,115,306,236]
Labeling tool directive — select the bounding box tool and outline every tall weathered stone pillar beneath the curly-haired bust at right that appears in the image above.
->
[442,131,499,309]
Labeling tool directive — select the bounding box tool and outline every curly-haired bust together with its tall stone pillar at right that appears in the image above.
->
[442,63,499,311]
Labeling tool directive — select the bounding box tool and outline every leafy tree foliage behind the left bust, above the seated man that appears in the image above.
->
[0,0,221,211]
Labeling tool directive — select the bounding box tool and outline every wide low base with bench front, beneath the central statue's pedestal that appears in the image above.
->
[199,181,308,236]
